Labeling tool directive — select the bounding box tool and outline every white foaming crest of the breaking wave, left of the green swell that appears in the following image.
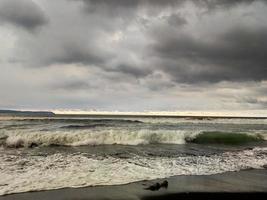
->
[3,129,198,147]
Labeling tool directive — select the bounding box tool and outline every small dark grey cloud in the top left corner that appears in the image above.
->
[0,0,48,31]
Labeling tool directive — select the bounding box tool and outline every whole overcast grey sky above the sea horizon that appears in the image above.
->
[0,0,267,111]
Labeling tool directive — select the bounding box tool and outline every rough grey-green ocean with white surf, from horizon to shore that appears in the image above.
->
[0,116,267,195]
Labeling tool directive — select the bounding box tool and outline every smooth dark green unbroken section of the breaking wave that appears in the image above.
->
[186,132,264,145]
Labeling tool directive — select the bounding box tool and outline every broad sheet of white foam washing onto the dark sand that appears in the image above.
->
[0,148,267,195]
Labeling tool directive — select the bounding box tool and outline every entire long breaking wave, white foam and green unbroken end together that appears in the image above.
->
[2,129,264,148]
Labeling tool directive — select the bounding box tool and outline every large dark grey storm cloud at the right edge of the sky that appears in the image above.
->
[153,27,267,83]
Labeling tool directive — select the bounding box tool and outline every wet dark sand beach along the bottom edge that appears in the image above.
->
[0,169,267,200]
